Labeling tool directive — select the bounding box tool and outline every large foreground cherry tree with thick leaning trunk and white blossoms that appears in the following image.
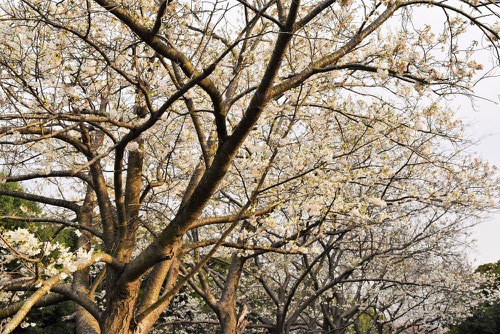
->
[0,0,500,333]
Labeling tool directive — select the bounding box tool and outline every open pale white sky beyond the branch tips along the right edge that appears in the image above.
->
[406,7,500,266]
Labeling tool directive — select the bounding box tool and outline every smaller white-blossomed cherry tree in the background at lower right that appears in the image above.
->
[182,106,495,333]
